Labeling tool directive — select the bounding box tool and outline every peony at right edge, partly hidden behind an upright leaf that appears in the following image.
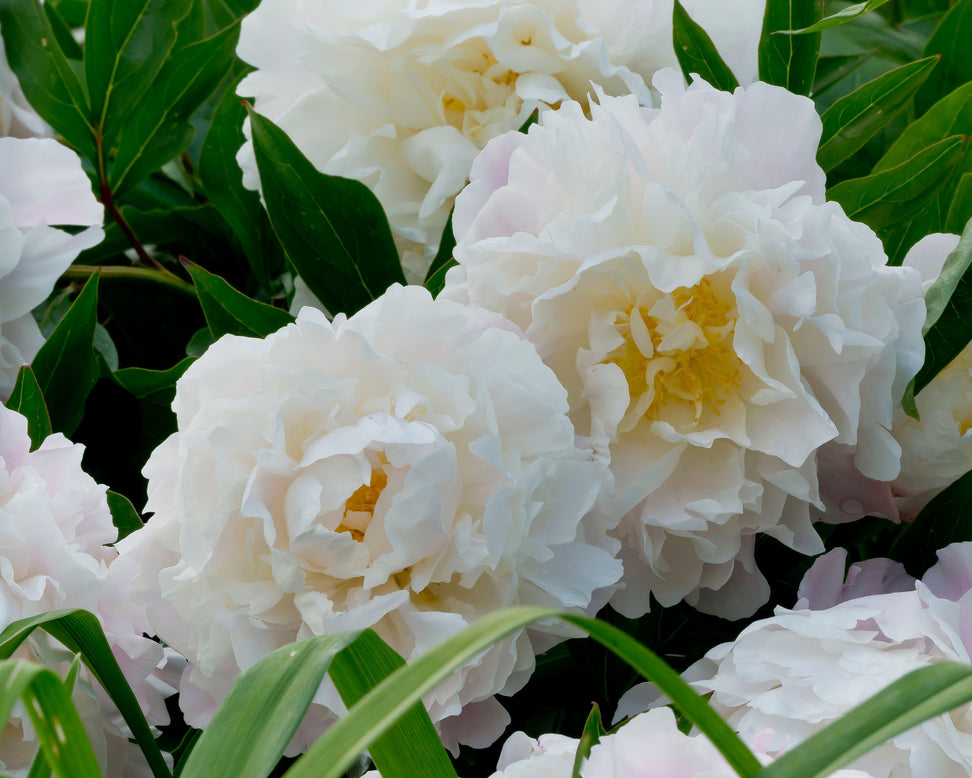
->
[891,233,972,520]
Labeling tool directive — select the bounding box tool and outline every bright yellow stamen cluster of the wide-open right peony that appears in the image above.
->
[607,278,742,426]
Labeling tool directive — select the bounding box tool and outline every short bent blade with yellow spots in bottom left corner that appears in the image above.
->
[0,659,101,778]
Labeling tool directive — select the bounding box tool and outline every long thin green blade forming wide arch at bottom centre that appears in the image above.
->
[284,606,759,778]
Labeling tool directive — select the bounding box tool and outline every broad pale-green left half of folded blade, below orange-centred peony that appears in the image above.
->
[180,632,357,778]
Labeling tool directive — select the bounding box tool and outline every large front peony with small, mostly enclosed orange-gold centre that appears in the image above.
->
[119,286,621,750]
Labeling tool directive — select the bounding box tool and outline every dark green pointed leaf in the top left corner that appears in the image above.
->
[0,0,97,160]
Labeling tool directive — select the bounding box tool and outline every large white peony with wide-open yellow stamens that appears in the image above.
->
[444,71,924,618]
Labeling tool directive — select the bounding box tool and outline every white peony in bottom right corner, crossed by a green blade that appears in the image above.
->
[622,543,972,778]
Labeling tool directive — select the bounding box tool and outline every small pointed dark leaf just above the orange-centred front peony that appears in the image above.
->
[183,261,294,338]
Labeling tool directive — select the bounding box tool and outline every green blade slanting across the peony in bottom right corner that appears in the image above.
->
[758,662,972,778]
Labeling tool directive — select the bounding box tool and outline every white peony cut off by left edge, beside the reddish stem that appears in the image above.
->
[0,138,104,400]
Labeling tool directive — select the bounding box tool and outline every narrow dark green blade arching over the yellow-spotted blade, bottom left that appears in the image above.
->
[0,610,170,778]
